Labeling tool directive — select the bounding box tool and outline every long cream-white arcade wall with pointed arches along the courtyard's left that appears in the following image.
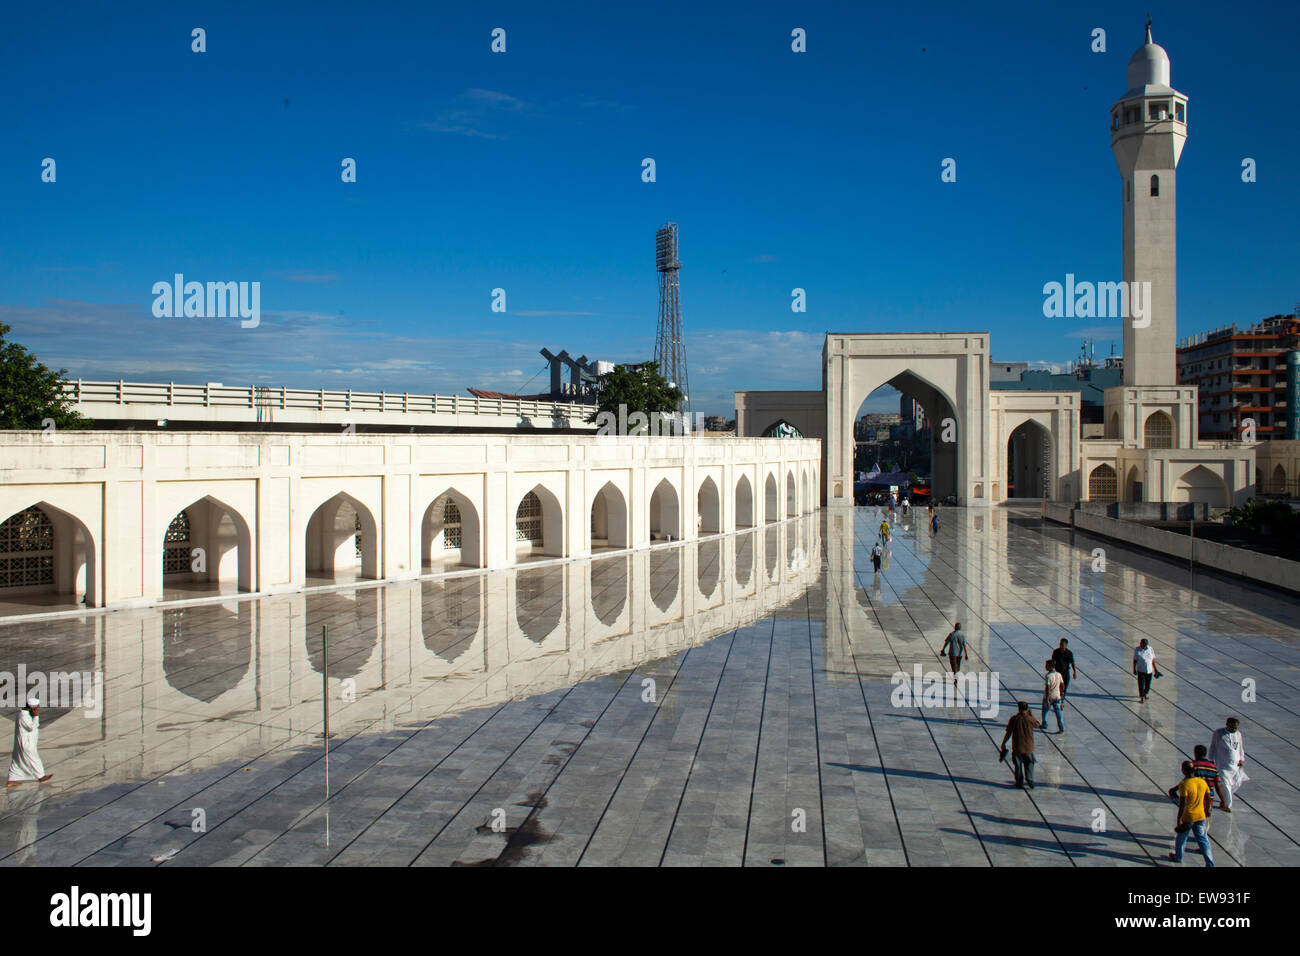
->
[0,431,822,606]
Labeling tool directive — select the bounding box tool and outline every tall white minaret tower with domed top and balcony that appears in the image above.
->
[1110,17,1187,385]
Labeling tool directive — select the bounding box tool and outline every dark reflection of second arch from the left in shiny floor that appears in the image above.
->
[161,601,254,721]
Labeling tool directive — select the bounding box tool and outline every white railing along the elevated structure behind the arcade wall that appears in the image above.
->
[62,378,593,424]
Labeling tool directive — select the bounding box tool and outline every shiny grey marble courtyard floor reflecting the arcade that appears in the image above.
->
[0,509,1300,866]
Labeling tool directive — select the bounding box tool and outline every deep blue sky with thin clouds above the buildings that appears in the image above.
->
[0,0,1300,415]
